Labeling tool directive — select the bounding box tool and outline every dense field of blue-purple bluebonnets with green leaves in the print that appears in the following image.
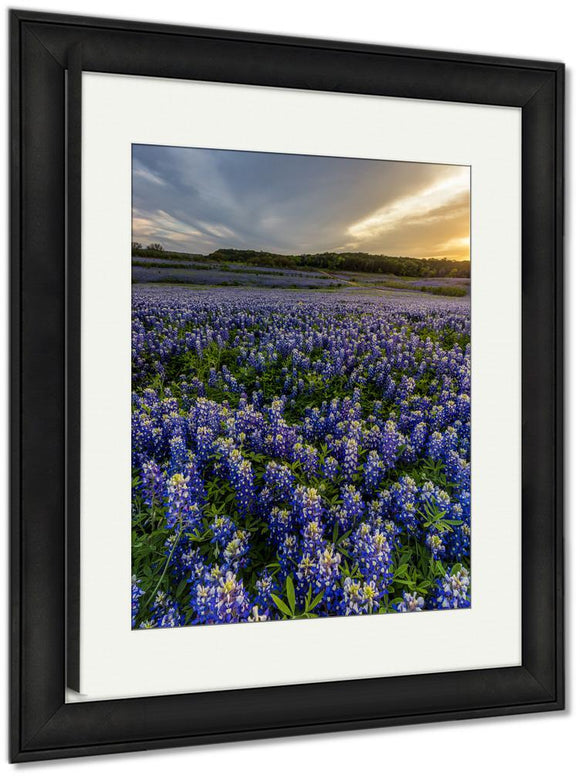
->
[132,287,471,628]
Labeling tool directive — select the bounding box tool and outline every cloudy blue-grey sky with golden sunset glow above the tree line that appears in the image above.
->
[133,145,470,260]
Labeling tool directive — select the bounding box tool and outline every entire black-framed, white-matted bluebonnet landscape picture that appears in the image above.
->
[11,6,564,761]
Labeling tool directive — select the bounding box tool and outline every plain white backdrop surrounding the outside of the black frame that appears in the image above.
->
[0,0,580,779]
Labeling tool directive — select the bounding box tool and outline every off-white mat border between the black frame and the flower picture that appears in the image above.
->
[80,73,521,700]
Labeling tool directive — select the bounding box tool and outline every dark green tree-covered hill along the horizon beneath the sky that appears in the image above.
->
[131,244,471,278]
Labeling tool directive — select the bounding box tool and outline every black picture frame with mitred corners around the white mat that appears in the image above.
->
[10,11,564,762]
